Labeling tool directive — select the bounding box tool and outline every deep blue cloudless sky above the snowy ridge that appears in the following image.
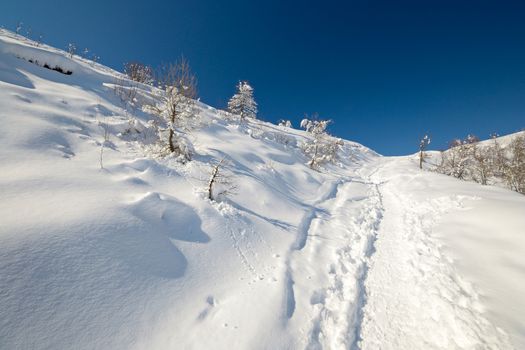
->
[0,0,525,155]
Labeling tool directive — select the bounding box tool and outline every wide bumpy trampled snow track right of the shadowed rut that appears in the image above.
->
[358,163,512,349]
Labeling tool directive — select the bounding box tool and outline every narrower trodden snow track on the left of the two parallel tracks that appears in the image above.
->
[288,165,383,349]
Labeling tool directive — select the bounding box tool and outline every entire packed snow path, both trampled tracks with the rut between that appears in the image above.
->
[288,158,512,349]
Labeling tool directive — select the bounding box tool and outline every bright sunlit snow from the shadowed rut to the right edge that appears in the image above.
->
[363,157,525,349]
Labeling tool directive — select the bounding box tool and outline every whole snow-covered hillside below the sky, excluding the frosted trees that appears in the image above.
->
[0,31,525,349]
